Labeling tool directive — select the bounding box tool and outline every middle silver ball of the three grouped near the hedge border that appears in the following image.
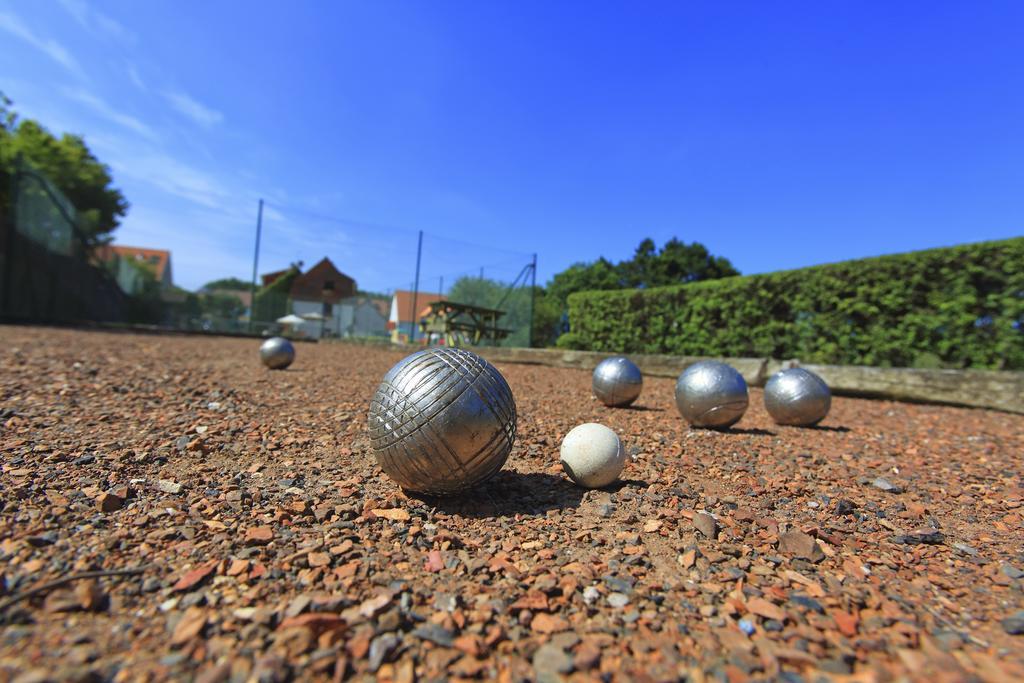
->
[676,360,750,429]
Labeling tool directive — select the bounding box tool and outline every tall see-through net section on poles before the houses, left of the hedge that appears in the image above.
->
[237,204,536,346]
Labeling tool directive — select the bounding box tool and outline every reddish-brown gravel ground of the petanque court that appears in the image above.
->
[0,327,1024,683]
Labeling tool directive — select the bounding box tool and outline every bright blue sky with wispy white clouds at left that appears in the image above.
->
[0,0,1024,290]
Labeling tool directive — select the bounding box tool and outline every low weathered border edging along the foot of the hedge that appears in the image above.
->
[474,347,1024,414]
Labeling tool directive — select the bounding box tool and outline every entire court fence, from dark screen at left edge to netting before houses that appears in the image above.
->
[0,167,537,346]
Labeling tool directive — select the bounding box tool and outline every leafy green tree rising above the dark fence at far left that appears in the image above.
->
[0,93,129,245]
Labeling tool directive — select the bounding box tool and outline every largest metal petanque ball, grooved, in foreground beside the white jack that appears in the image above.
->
[370,347,516,496]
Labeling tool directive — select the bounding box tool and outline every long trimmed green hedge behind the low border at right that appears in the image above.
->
[559,238,1024,370]
